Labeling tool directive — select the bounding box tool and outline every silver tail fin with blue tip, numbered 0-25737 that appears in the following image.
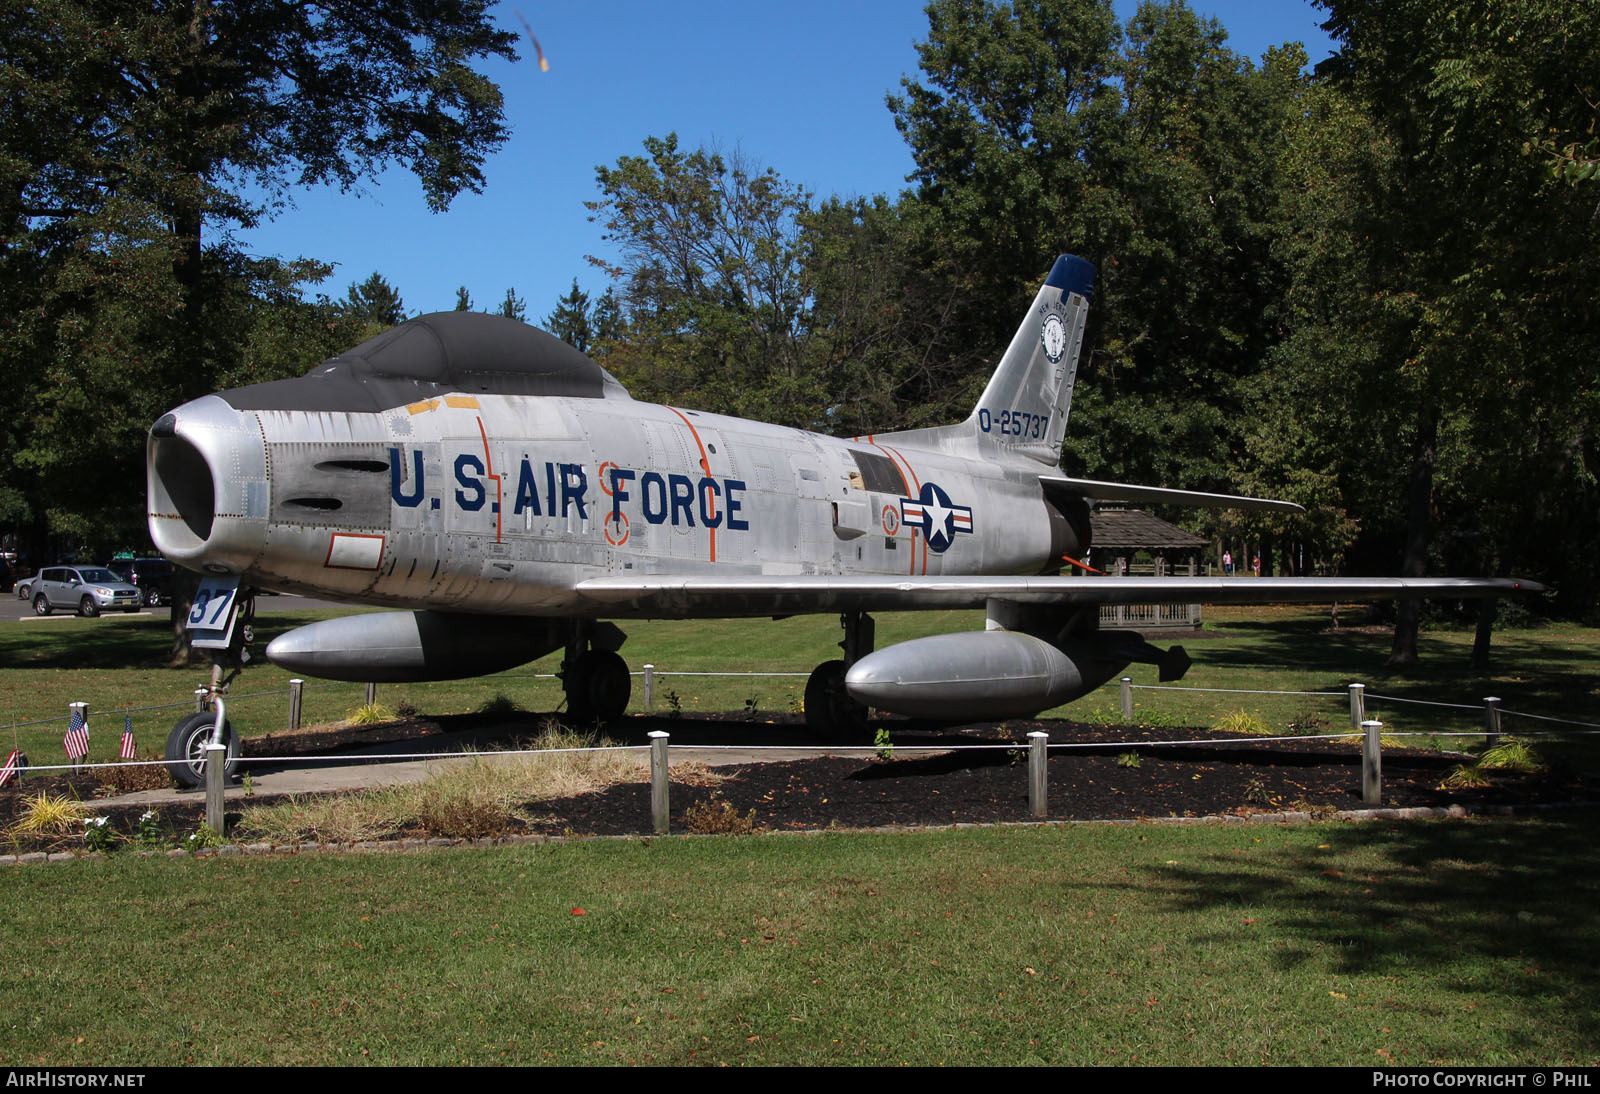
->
[968,254,1094,467]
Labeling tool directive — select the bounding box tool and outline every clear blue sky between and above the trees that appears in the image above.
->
[237,0,1331,321]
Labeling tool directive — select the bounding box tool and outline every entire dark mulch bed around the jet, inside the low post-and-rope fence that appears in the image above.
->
[0,715,1600,849]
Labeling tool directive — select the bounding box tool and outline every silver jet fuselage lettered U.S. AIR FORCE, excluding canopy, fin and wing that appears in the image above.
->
[150,389,1080,617]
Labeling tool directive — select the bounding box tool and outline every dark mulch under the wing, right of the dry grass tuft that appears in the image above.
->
[518,721,1600,835]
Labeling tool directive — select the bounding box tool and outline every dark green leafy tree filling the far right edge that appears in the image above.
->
[1302,0,1600,649]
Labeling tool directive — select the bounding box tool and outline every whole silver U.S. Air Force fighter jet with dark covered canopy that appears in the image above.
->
[147,254,1530,780]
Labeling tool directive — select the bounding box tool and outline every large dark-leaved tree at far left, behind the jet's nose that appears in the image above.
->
[0,0,514,559]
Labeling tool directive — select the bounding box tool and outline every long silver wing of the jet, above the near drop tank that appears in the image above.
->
[574,574,1544,617]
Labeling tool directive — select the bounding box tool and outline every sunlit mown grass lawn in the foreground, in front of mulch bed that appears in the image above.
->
[0,814,1600,1067]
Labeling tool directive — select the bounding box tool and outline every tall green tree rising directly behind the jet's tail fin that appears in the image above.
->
[890,0,1304,489]
